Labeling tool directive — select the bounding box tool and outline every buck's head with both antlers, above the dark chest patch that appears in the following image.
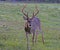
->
[22,4,39,32]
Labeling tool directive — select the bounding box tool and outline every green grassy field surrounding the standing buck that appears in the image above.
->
[0,3,60,50]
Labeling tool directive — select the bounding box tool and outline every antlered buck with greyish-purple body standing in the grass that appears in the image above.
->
[22,5,44,44]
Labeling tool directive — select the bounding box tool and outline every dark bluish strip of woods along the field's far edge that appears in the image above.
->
[0,0,60,3]
